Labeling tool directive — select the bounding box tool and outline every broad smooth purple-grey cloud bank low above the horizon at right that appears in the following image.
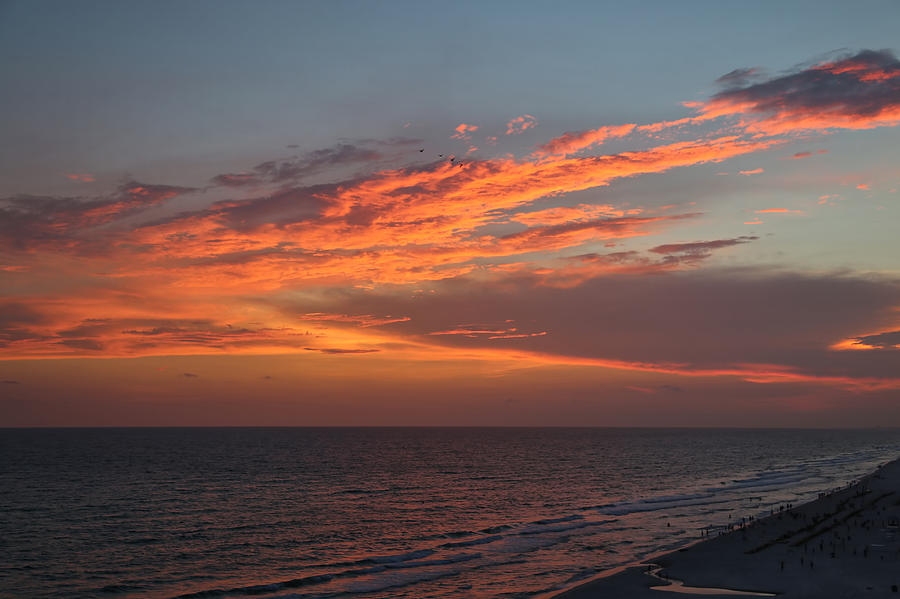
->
[282,268,900,377]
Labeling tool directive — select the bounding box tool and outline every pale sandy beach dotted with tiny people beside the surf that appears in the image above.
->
[556,460,900,599]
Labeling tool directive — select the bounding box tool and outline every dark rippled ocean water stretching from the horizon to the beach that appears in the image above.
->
[0,428,900,599]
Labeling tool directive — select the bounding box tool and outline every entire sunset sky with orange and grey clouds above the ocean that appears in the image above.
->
[0,0,900,427]
